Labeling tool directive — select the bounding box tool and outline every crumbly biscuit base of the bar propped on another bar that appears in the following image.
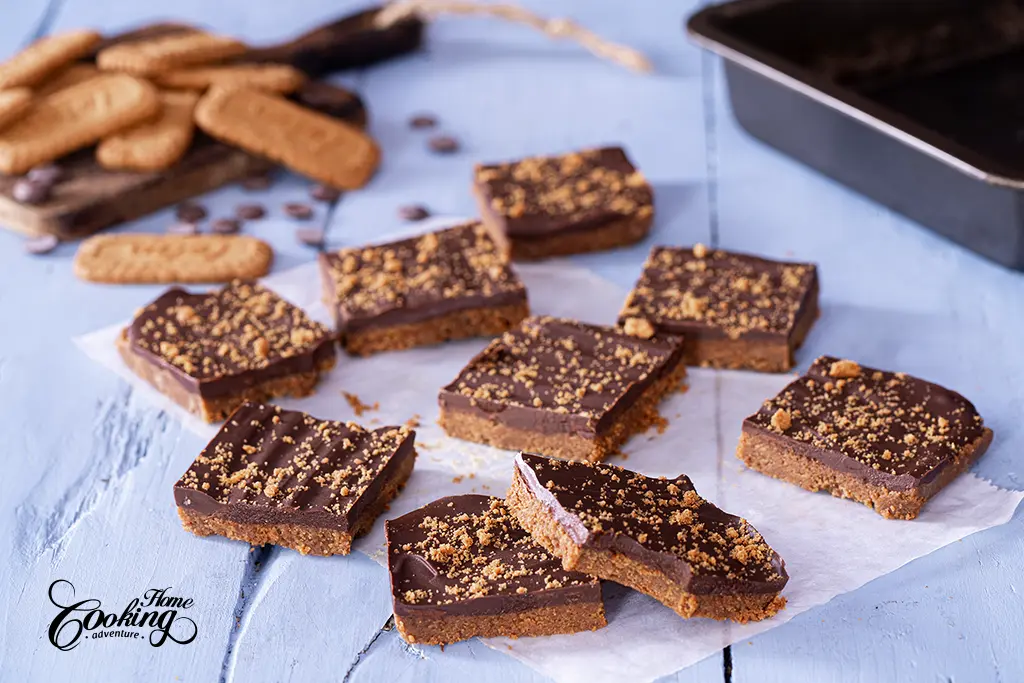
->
[505,471,785,624]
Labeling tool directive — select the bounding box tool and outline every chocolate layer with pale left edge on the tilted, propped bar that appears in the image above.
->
[515,453,788,595]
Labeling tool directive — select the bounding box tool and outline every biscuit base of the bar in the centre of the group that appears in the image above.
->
[438,360,686,463]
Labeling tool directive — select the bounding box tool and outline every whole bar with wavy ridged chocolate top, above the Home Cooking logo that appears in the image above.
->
[174,402,416,555]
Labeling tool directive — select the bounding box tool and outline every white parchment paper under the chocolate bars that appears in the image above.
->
[75,218,1024,683]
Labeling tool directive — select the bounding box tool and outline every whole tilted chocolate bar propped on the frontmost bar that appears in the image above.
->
[508,454,788,622]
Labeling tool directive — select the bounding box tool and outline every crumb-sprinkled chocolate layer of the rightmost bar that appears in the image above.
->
[743,356,985,490]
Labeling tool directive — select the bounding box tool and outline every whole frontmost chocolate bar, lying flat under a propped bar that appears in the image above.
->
[385,496,604,643]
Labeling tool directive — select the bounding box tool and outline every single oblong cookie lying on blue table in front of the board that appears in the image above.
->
[75,233,273,285]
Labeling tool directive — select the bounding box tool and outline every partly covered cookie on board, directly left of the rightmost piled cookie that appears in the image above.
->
[96,91,199,172]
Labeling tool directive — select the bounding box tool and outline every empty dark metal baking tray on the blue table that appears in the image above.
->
[687,0,1024,270]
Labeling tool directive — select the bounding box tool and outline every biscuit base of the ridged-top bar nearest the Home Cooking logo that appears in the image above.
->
[178,452,416,556]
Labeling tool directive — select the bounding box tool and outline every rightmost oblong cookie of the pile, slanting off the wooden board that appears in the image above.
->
[196,88,380,189]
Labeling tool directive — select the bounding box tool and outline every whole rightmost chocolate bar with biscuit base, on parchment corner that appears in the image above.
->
[737,356,992,518]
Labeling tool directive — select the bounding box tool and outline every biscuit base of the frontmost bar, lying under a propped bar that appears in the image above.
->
[394,601,607,645]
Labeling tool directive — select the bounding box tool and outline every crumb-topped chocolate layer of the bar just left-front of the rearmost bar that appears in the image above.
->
[321,222,526,334]
